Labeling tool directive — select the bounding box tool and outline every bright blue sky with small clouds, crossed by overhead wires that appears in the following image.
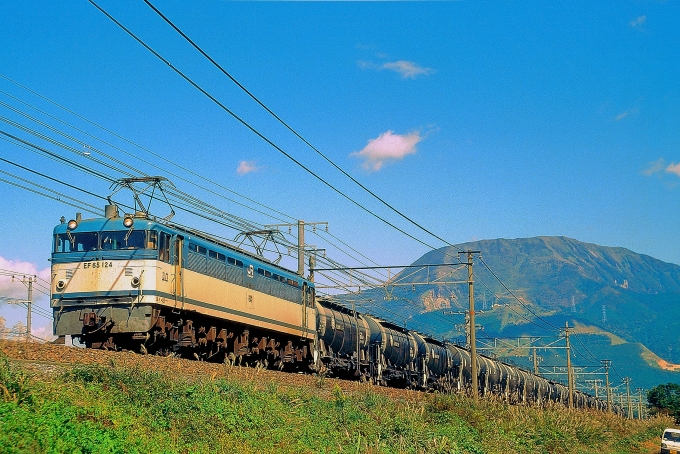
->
[0,0,680,336]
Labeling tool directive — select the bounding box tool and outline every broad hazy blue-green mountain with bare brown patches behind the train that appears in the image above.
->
[342,237,680,388]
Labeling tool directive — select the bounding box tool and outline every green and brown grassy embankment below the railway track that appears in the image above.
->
[0,353,673,454]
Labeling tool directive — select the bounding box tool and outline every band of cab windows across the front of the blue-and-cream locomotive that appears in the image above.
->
[54,230,158,253]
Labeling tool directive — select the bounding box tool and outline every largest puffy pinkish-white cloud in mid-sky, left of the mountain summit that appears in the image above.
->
[350,131,423,172]
